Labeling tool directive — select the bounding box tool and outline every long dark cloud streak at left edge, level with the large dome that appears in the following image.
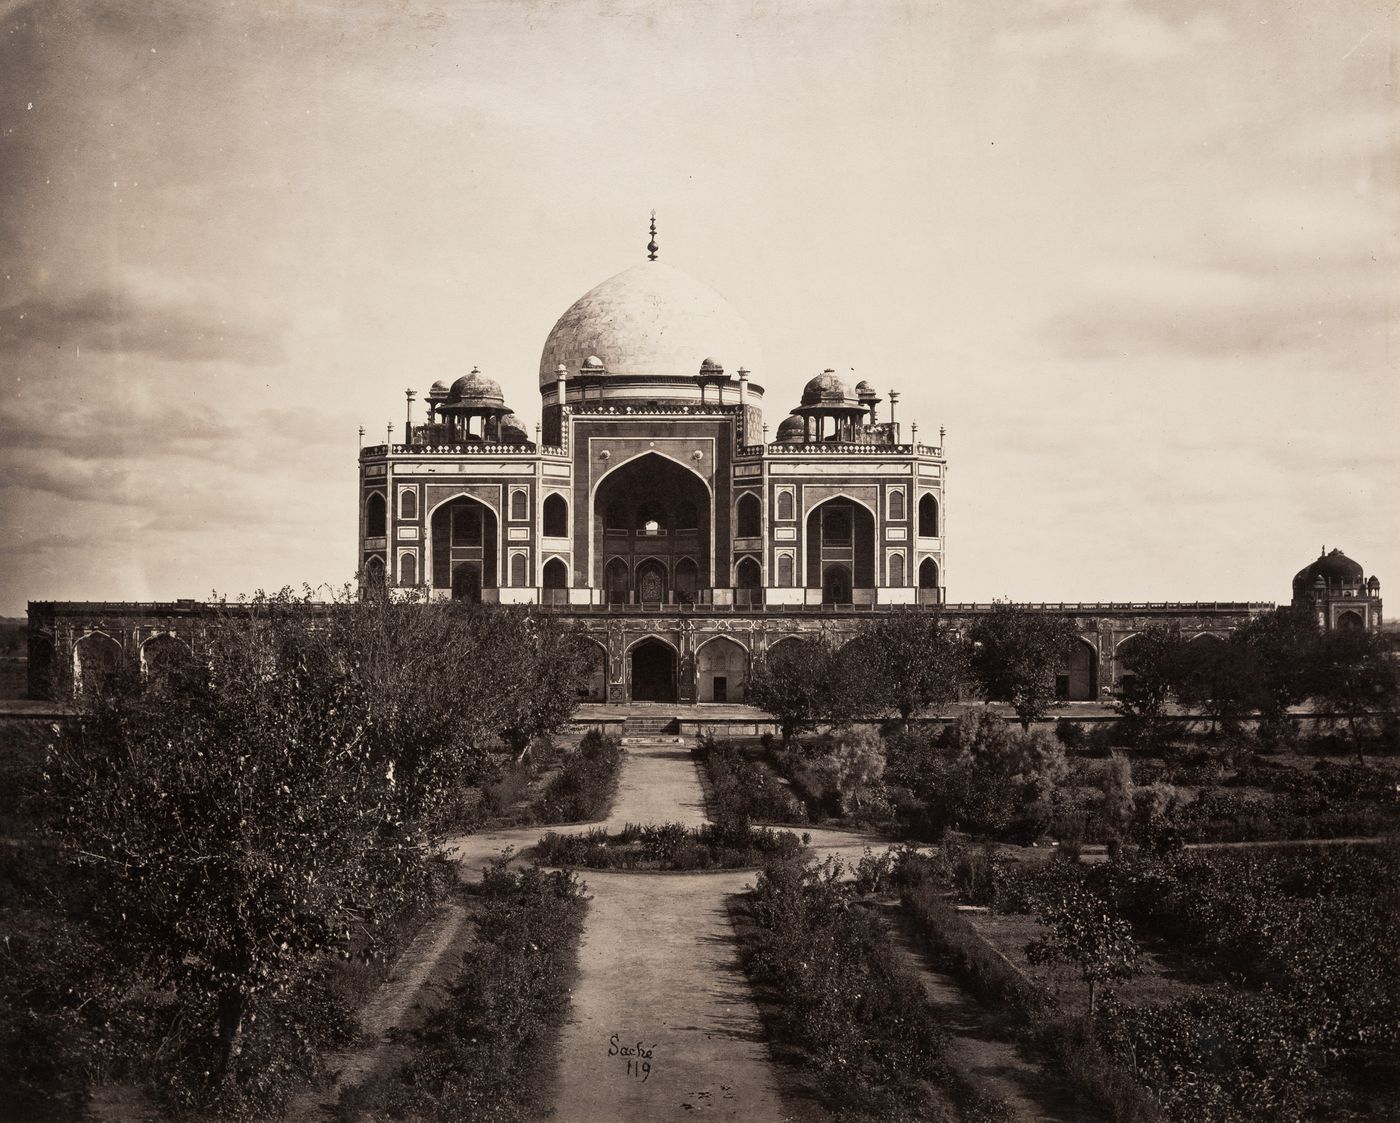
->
[0,286,283,365]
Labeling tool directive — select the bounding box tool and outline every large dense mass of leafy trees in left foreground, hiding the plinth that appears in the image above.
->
[48,592,574,1115]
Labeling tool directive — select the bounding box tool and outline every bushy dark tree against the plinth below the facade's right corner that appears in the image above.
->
[864,609,966,730]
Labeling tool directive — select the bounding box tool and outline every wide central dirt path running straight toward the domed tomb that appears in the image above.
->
[537,738,788,1123]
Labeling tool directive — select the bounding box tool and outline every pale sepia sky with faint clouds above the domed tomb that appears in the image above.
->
[0,0,1400,615]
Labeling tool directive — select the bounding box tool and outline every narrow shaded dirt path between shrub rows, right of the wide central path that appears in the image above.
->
[885,906,1095,1123]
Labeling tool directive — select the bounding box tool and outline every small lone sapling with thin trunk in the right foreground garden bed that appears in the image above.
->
[1026,878,1142,1017]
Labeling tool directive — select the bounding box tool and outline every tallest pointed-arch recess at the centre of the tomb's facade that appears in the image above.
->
[592,452,711,604]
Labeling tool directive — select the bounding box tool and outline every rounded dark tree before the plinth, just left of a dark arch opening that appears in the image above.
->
[969,602,1078,731]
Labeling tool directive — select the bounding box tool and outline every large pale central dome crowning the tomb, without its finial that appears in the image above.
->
[539,262,763,389]
